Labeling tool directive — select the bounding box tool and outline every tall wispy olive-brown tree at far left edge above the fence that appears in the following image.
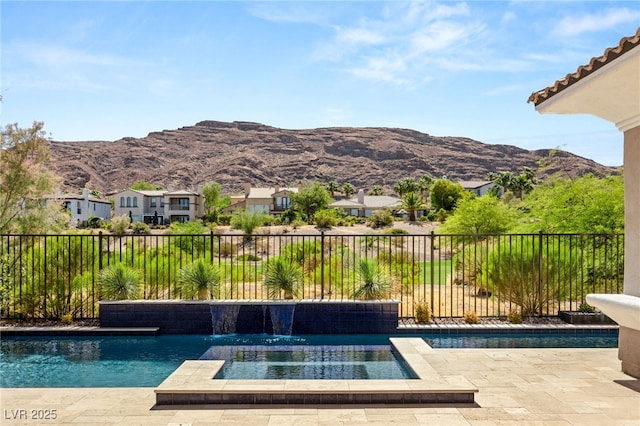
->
[0,122,63,234]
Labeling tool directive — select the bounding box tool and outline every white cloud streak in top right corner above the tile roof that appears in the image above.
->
[553,8,640,37]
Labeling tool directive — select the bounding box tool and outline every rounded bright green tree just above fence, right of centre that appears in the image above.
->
[440,195,514,235]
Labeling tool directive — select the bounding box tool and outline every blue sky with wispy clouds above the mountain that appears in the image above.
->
[0,0,640,166]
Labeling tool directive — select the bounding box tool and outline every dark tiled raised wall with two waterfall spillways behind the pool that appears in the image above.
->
[100,300,399,335]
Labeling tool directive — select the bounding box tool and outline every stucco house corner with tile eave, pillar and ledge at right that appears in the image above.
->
[528,28,640,378]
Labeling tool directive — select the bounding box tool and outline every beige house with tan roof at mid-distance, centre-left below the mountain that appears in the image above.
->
[224,184,298,216]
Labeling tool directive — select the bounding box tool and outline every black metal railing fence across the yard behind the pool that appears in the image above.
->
[0,233,624,318]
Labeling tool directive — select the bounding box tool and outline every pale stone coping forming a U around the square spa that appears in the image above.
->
[154,338,478,406]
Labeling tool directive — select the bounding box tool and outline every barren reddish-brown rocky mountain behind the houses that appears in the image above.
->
[51,121,617,194]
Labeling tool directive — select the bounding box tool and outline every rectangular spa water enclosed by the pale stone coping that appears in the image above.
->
[200,345,417,380]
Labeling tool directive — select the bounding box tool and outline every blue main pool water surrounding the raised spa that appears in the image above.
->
[0,334,618,388]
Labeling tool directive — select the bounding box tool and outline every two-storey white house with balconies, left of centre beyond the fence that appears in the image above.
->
[114,189,204,225]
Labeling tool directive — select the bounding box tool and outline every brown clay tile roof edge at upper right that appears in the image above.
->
[527,27,640,106]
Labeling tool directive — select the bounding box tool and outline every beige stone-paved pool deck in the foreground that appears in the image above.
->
[0,348,640,426]
